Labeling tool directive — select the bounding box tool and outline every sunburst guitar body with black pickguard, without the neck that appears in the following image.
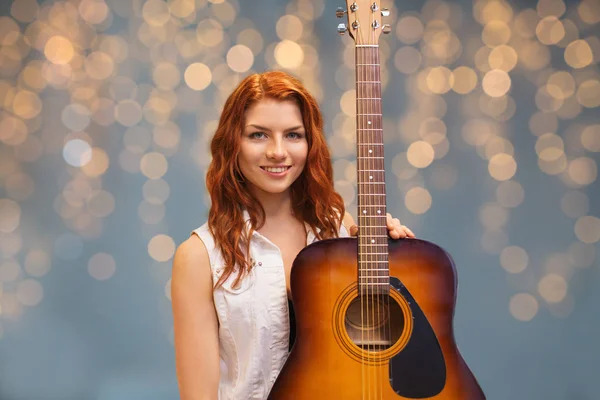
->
[269,238,485,400]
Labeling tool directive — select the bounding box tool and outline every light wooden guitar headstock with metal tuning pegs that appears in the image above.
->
[336,0,391,45]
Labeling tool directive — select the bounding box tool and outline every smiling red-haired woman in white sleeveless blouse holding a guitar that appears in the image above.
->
[171,72,414,400]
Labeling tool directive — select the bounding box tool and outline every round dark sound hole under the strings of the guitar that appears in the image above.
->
[344,295,404,352]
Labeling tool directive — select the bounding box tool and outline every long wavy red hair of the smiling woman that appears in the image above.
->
[206,71,345,288]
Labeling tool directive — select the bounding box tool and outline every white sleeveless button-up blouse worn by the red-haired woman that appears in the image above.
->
[192,212,349,400]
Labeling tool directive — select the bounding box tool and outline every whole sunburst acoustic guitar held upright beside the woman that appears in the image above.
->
[269,0,485,400]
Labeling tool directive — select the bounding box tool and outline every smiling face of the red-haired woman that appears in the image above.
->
[238,98,308,198]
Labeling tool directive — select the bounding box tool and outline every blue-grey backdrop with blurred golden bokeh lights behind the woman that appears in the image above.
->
[0,0,600,400]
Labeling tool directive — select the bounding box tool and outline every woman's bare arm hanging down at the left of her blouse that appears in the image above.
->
[171,235,219,400]
